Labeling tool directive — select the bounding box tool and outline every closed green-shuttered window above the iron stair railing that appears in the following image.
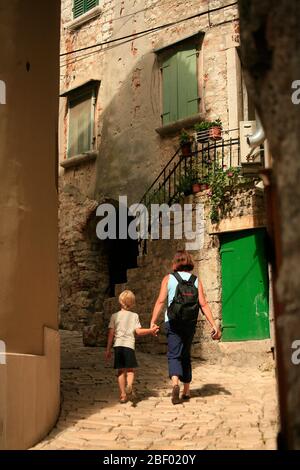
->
[161,43,199,125]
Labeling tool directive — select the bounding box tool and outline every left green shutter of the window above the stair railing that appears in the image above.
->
[162,54,178,125]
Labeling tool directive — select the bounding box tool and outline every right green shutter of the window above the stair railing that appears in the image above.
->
[177,46,199,119]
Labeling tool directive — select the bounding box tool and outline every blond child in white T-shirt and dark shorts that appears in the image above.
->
[105,290,159,403]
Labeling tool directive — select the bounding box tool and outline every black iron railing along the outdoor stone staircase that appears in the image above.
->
[141,138,240,207]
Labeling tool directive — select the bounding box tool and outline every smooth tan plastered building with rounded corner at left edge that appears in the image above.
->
[0,0,60,450]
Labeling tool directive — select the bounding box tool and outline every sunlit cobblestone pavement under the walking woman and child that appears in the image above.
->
[35,331,277,450]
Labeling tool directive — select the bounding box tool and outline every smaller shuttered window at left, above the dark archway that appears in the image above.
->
[65,80,99,158]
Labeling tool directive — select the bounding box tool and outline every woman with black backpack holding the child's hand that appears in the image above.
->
[150,250,221,405]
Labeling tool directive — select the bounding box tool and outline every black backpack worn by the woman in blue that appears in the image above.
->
[167,272,200,323]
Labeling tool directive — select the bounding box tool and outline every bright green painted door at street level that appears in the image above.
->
[221,229,270,341]
